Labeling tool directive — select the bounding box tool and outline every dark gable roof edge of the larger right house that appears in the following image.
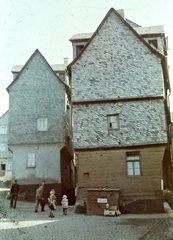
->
[67,8,164,70]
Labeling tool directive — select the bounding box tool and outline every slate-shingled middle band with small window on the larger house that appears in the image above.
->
[73,100,167,148]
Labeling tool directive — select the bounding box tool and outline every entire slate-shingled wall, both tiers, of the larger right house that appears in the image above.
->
[72,12,167,148]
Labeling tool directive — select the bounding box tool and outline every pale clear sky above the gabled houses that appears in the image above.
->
[0,0,173,116]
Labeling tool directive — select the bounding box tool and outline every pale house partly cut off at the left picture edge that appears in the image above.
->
[0,111,12,182]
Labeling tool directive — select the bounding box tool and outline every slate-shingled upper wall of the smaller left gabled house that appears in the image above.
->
[9,53,65,144]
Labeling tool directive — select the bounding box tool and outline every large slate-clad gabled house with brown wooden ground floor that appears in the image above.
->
[67,8,172,214]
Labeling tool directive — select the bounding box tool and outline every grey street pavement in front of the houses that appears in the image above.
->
[0,189,173,240]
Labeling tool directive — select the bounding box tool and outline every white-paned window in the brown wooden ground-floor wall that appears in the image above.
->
[126,152,141,176]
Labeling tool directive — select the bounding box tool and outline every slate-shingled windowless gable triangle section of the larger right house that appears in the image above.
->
[72,13,164,101]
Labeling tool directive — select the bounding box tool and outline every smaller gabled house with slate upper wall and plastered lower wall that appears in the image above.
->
[7,50,75,201]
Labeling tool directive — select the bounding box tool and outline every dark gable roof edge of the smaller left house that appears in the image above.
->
[6,49,68,92]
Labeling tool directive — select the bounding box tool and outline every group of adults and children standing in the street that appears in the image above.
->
[10,180,68,218]
